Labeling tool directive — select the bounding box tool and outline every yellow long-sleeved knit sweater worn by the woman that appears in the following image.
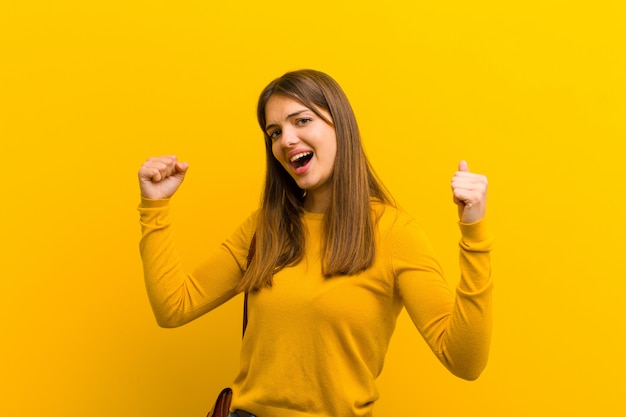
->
[139,199,492,417]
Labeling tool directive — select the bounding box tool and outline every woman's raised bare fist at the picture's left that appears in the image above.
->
[138,156,189,200]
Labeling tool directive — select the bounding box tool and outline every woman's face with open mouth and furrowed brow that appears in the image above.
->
[265,95,337,206]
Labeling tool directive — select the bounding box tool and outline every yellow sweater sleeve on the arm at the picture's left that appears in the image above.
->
[138,199,253,327]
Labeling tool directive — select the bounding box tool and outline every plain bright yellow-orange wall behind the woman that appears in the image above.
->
[0,0,626,417]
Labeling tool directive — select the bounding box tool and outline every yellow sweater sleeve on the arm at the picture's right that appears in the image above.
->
[393,220,493,380]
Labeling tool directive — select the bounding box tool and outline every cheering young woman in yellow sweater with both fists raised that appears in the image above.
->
[139,70,492,417]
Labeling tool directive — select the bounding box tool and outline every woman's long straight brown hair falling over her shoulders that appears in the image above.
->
[240,70,394,290]
